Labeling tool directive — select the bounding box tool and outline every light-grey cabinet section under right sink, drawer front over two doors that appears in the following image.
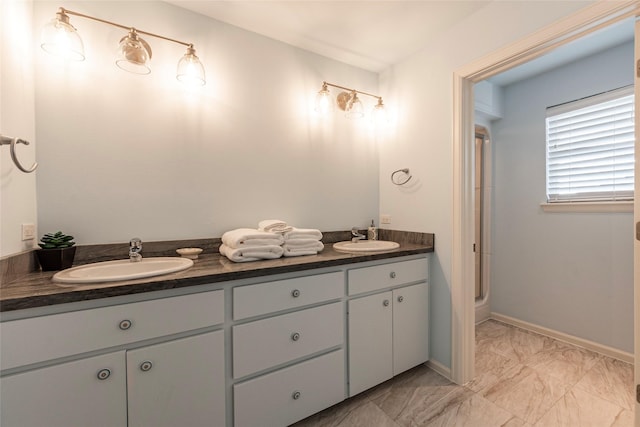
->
[348,259,429,396]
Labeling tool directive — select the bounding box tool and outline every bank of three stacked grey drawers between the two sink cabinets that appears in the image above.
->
[232,272,345,427]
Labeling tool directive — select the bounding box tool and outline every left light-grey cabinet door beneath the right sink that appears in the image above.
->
[349,291,393,396]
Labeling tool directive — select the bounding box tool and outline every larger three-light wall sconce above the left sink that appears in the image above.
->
[40,7,206,86]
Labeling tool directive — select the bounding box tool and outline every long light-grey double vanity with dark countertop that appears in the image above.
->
[0,232,433,427]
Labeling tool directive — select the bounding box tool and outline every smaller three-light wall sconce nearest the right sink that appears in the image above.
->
[316,82,386,122]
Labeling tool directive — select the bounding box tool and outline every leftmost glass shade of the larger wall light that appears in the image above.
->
[40,12,84,61]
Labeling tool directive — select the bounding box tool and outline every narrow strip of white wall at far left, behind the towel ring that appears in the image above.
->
[0,0,37,256]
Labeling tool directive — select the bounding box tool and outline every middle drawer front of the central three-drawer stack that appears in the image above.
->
[233,302,344,378]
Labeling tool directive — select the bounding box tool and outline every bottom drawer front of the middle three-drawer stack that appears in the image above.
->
[233,350,345,427]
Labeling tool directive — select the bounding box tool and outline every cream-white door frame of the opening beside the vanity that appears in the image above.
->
[451,0,640,384]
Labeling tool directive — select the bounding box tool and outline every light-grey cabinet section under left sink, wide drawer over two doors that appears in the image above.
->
[0,291,225,427]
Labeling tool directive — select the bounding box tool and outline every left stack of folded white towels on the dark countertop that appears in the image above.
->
[219,228,284,262]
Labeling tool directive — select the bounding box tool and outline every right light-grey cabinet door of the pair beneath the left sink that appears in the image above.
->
[127,331,225,427]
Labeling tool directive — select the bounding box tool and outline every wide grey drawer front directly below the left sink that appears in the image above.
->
[0,291,224,370]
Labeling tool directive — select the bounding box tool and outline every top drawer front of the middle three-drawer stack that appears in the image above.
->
[233,272,344,320]
